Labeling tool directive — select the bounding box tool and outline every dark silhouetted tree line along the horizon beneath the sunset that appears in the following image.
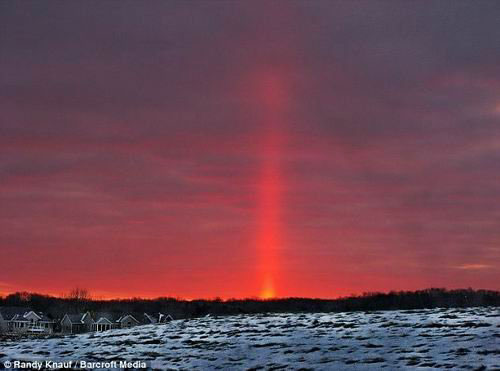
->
[0,288,500,319]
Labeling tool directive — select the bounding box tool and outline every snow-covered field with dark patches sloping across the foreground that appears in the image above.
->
[0,308,500,370]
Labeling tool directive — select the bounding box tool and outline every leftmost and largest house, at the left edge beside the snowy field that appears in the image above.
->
[2,308,56,334]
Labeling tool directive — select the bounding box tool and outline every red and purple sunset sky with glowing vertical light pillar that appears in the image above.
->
[0,0,500,298]
